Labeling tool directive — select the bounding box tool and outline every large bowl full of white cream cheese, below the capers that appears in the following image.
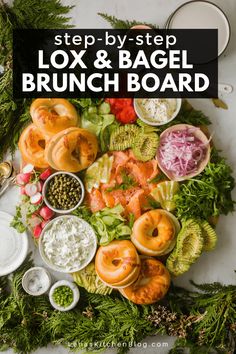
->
[39,215,97,273]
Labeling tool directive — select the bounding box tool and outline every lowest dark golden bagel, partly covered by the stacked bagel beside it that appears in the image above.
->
[119,256,171,305]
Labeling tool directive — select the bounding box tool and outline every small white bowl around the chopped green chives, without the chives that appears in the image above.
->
[49,280,80,311]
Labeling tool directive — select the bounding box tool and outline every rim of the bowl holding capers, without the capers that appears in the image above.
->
[42,171,85,214]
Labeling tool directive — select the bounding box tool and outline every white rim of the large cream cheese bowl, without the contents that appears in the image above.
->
[39,215,97,273]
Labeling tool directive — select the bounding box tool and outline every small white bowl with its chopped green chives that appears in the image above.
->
[49,280,80,311]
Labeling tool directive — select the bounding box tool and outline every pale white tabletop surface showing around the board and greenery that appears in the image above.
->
[0,0,236,354]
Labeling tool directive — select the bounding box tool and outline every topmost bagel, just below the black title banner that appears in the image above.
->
[30,98,79,136]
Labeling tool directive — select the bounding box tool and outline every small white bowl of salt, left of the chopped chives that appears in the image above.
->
[22,267,51,296]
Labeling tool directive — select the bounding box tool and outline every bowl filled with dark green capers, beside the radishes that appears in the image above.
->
[43,171,85,214]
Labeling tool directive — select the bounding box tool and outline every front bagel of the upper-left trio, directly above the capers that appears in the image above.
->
[45,127,98,172]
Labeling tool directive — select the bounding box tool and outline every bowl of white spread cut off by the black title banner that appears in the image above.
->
[134,98,182,126]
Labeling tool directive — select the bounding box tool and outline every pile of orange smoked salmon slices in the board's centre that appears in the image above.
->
[88,150,159,219]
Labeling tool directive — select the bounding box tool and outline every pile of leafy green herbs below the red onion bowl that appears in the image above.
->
[174,149,235,220]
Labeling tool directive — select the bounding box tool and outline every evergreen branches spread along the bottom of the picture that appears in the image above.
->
[0,255,236,354]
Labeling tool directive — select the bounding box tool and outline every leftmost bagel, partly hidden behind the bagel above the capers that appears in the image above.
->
[18,124,49,169]
